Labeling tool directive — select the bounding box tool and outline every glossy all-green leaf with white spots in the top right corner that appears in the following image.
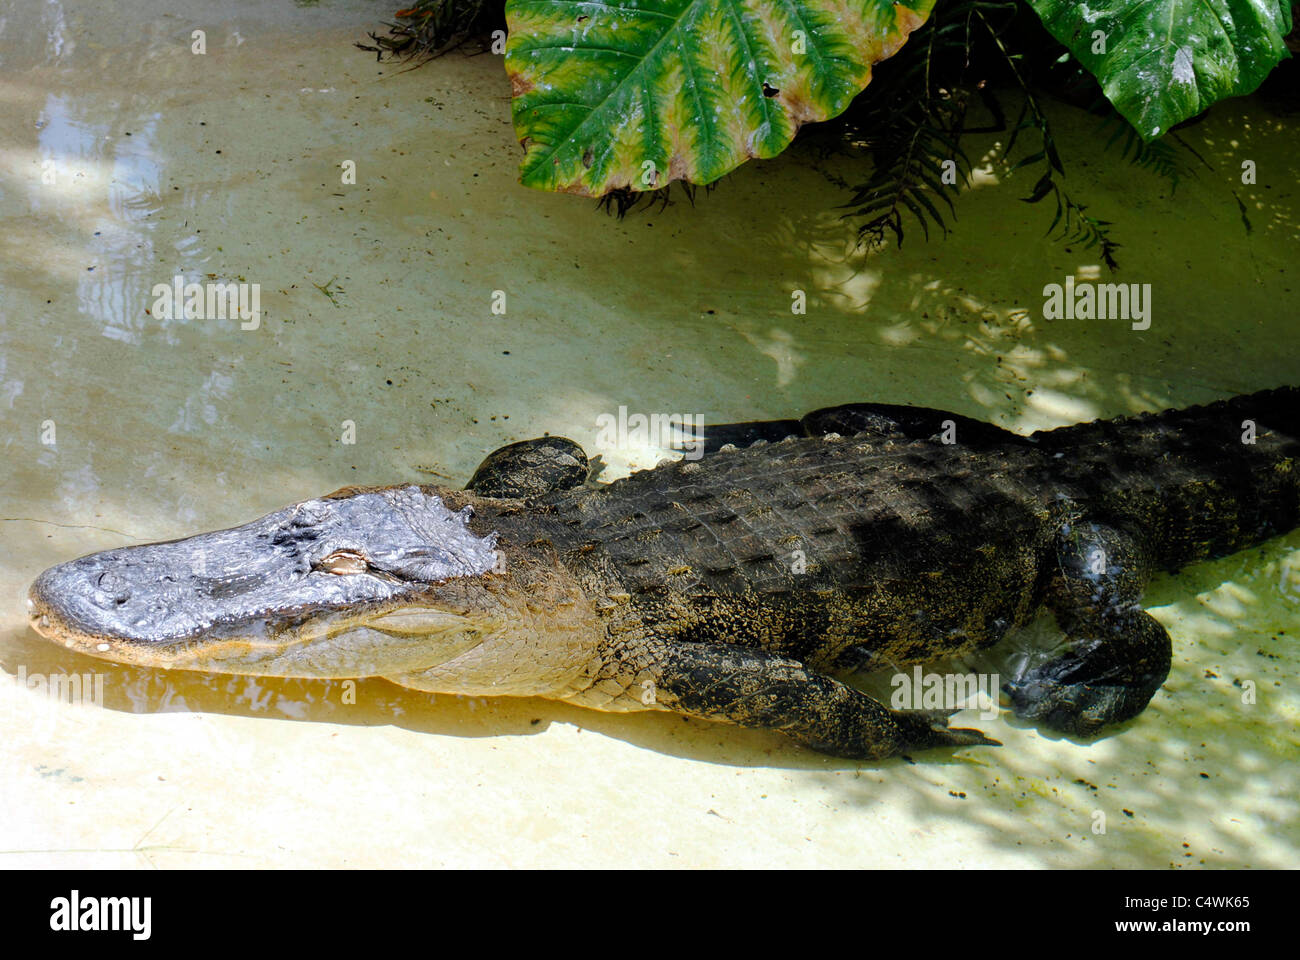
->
[1030,0,1291,140]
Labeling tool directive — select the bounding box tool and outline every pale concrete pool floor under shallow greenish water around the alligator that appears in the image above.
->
[0,0,1300,866]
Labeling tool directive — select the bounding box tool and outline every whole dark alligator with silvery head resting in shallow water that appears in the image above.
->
[27,388,1300,760]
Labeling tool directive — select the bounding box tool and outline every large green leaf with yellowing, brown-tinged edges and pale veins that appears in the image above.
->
[506,0,935,196]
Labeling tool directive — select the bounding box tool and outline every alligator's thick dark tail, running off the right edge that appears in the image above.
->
[1035,388,1300,570]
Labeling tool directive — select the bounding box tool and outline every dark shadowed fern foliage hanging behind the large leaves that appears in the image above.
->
[356,0,1206,269]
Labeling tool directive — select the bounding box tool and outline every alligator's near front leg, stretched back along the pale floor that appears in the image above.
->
[651,643,998,760]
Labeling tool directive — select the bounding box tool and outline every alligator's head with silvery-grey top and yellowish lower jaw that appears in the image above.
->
[27,485,502,678]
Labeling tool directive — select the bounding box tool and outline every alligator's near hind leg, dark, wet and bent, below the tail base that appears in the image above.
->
[1002,523,1171,736]
